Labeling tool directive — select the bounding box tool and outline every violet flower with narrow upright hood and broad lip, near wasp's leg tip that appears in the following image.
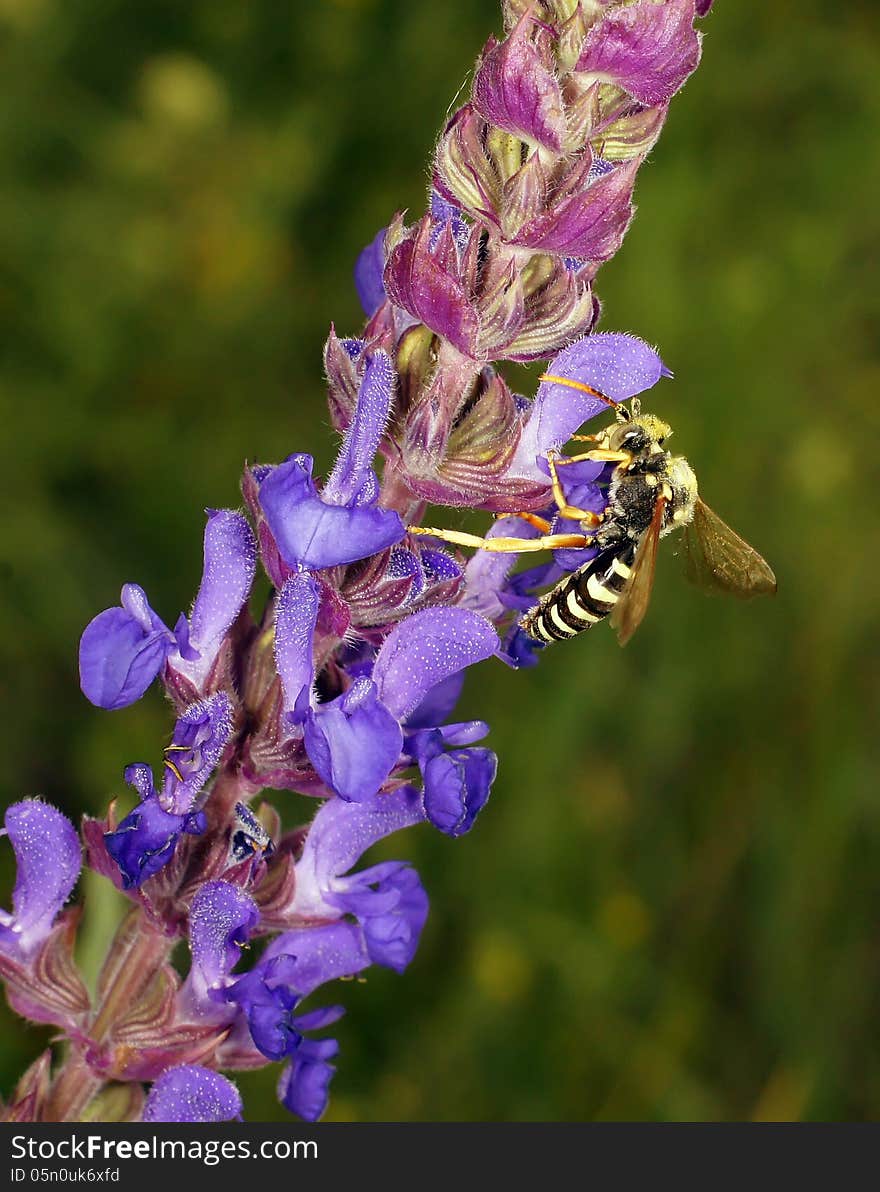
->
[260,352,405,570]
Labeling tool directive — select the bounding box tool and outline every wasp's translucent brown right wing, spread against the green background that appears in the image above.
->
[684,497,776,600]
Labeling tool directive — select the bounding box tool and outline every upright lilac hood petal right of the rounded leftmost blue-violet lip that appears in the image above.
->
[173,509,256,687]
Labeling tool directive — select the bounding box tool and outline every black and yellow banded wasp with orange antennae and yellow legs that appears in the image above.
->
[411,374,776,645]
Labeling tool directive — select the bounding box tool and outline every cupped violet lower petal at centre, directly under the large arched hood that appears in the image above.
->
[304,678,403,802]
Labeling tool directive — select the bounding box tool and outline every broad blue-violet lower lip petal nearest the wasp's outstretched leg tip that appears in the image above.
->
[260,455,405,570]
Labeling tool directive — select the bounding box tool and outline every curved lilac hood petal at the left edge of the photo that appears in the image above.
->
[0,799,82,956]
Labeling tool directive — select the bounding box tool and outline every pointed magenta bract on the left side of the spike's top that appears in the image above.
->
[473,11,565,153]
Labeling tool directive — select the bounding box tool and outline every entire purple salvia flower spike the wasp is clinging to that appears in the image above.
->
[0,0,709,1122]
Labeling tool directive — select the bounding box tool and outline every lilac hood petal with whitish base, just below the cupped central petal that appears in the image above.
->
[295,787,424,915]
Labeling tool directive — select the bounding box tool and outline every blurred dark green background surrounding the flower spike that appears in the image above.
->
[0,0,880,1120]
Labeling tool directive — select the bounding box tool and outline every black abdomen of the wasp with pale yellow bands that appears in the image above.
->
[520,542,636,642]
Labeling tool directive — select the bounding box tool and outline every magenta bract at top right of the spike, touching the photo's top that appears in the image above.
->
[576,0,708,106]
